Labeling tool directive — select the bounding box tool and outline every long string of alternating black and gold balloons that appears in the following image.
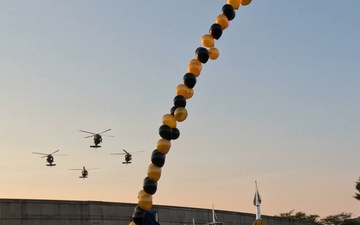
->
[130,0,251,225]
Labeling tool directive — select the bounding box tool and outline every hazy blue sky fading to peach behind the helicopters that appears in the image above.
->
[0,0,360,216]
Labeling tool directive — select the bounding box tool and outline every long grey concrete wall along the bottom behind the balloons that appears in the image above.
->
[0,199,314,225]
